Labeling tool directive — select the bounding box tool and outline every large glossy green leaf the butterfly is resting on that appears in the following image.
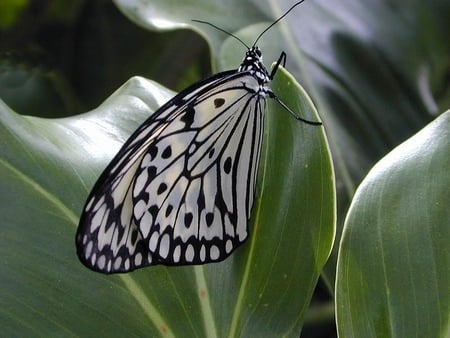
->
[0,57,334,337]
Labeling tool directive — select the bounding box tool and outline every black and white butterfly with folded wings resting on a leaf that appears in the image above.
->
[76,1,320,273]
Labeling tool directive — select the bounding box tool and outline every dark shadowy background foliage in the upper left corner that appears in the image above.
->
[0,0,211,117]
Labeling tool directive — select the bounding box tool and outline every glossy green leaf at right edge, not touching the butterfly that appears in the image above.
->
[336,111,450,337]
